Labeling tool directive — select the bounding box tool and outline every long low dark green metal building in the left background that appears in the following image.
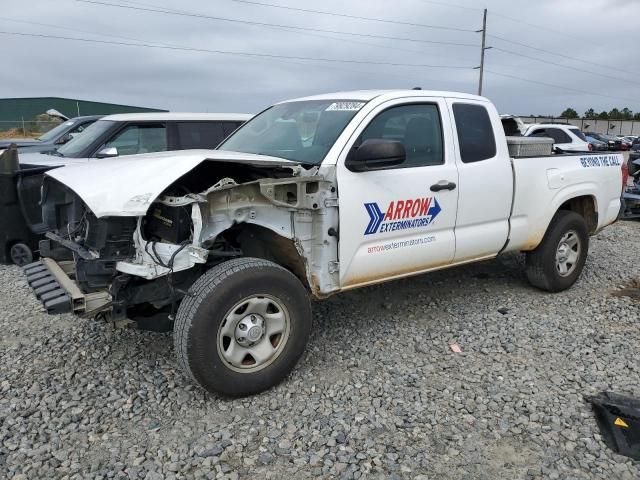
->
[0,97,167,130]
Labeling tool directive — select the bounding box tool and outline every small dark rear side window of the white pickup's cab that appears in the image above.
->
[453,103,496,163]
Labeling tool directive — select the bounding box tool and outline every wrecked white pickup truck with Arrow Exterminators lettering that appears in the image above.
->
[25,90,625,396]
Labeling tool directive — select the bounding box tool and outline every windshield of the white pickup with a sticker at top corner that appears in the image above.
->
[218,100,365,165]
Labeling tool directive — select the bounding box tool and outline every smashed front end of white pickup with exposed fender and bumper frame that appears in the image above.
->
[25,156,338,319]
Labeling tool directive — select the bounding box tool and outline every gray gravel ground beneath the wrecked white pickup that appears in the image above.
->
[0,223,640,480]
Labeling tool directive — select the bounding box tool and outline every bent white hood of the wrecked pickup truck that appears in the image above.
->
[47,150,299,218]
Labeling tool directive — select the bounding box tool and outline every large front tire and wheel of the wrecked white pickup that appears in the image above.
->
[174,258,312,397]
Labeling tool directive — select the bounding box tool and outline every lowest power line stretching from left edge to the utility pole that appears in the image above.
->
[0,31,471,70]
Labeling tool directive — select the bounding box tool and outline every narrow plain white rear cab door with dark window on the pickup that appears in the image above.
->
[447,99,514,263]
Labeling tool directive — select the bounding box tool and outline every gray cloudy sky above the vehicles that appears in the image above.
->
[0,0,640,115]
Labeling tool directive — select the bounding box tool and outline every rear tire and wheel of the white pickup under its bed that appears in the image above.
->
[526,210,589,292]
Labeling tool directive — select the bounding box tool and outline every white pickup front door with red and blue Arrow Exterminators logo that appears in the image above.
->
[337,97,458,288]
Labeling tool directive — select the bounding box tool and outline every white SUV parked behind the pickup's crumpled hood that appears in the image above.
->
[20,112,251,167]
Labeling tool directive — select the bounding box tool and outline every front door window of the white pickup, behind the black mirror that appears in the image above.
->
[356,104,444,168]
